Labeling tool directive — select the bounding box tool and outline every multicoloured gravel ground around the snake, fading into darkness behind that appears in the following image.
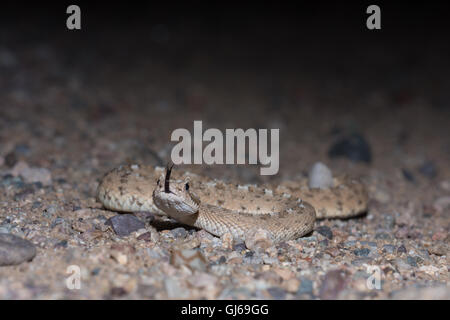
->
[0,6,450,299]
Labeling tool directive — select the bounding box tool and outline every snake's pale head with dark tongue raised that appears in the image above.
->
[153,164,200,220]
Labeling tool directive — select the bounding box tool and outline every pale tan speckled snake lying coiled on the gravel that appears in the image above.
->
[97,165,368,242]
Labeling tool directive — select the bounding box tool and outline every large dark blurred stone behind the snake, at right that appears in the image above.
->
[328,133,372,163]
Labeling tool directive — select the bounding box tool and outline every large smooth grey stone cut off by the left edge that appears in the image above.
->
[0,233,36,266]
